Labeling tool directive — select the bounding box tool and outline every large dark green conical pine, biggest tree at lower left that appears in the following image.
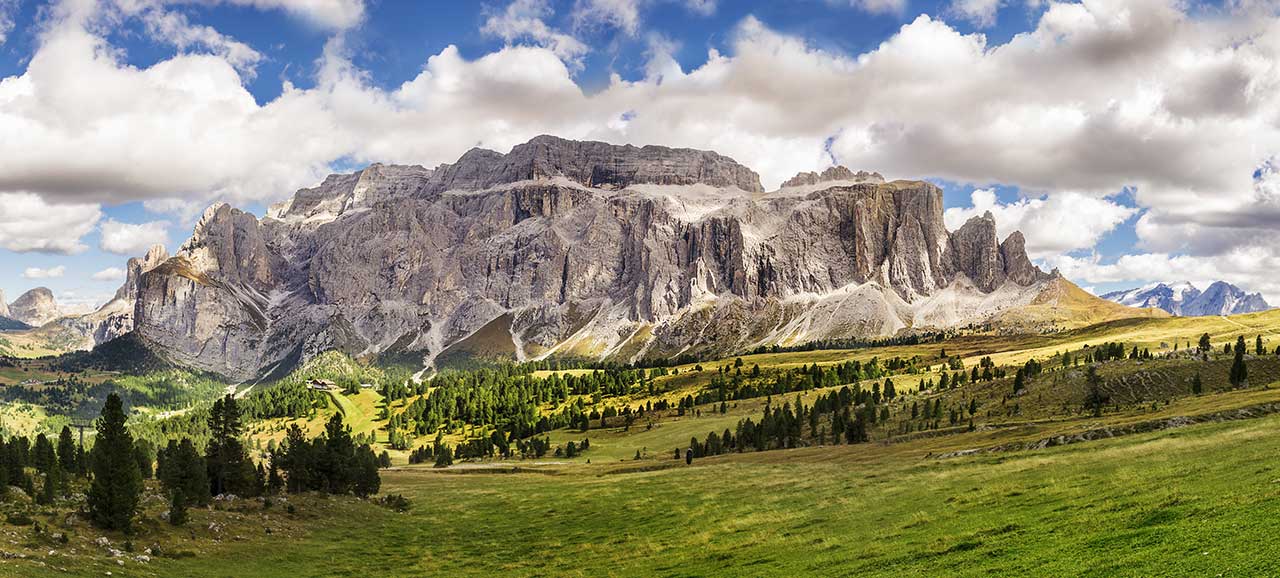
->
[88,393,142,532]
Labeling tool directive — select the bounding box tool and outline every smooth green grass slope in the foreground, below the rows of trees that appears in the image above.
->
[15,389,1280,577]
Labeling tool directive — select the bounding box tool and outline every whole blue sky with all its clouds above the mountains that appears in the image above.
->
[0,0,1280,315]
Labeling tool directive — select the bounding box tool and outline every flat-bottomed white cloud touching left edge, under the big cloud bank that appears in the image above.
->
[0,191,102,254]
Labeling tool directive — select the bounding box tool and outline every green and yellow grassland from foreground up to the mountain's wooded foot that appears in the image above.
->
[0,312,1280,577]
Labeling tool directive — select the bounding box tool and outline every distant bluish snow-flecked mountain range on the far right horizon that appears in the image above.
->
[1102,281,1271,317]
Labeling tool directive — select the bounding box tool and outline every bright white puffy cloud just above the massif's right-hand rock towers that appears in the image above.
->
[943,189,1138,258]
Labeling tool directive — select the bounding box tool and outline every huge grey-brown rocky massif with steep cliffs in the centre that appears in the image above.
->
[134,137,1048,379]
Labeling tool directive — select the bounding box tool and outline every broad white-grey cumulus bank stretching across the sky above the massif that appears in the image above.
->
[0,0,1280,271]
